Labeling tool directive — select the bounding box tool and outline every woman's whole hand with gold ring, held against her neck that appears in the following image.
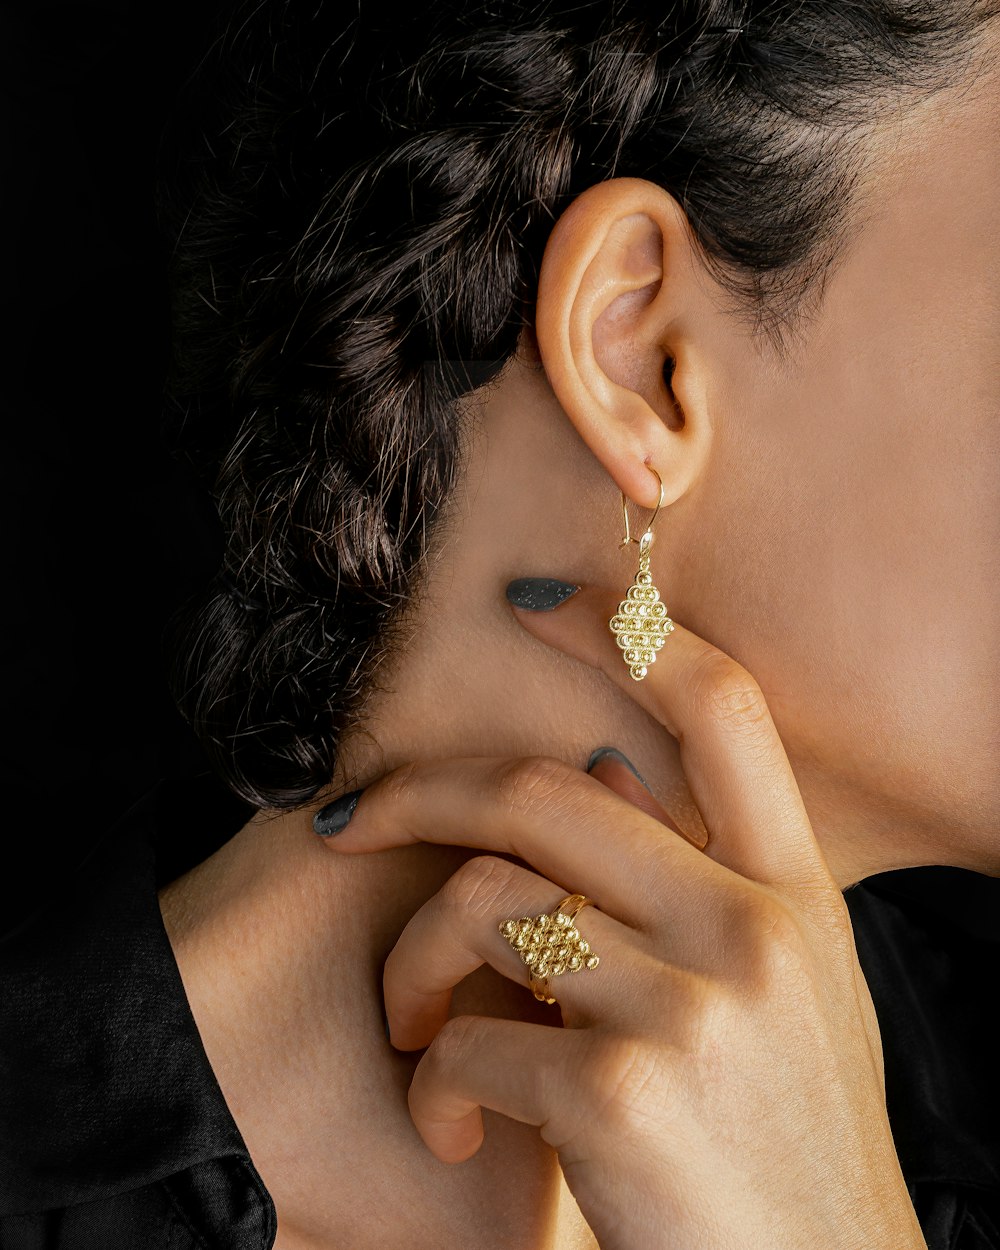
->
[316,589,925,1250]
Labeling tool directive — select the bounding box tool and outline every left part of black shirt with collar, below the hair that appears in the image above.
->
[0,786,275,1250]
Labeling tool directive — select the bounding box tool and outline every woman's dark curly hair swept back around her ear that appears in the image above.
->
[159,0,1000,808]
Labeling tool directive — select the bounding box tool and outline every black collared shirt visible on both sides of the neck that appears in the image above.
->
[0,783,1000,1250]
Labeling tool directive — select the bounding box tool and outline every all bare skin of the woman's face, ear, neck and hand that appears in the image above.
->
[163,35,1000,1250]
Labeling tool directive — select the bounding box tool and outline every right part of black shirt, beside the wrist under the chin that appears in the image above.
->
[845,873,1000,1250]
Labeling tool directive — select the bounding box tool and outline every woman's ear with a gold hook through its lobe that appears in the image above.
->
[535,178,719,509]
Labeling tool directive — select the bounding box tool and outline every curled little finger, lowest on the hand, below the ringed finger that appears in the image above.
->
[409,1016,589,1164]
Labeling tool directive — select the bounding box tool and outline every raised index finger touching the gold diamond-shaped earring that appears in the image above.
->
[511,586,833,886]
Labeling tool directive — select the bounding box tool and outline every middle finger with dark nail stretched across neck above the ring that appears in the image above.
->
[316,755,724,930]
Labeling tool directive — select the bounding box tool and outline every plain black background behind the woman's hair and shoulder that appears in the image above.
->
[0,0,1000,935]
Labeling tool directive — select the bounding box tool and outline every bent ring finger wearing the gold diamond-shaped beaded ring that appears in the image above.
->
[383,855,648,1050]
